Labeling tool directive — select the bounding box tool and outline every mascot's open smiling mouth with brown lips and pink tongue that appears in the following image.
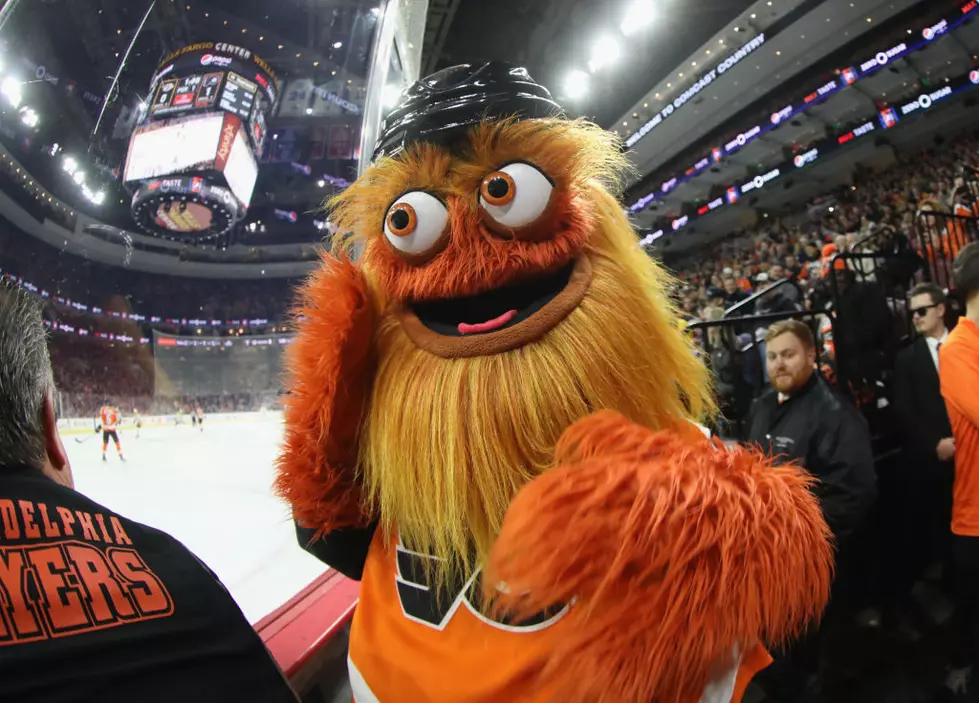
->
[396,256,592,357]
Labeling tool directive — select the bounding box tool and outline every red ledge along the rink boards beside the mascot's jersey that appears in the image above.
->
[255,569,360,680]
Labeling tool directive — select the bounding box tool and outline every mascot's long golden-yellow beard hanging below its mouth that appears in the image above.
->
[359,187,713,583]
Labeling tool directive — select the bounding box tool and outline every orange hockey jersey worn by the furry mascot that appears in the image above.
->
[348,530,771,703]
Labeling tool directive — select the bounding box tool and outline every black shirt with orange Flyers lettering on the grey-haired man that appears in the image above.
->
[0,468,297,703]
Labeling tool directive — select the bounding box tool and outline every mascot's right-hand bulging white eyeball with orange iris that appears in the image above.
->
[479,161,554,229]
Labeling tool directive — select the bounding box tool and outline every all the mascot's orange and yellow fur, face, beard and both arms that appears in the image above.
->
[277,114,831,703]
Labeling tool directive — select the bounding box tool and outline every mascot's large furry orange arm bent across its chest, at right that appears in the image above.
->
[485,411,832,703]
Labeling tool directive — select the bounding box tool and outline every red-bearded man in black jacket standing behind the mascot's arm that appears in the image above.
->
[748,320,877,703]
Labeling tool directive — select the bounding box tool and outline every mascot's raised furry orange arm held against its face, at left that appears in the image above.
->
[276,256,375,533]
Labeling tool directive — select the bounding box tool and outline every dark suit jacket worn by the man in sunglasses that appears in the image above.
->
[893,337,952,463]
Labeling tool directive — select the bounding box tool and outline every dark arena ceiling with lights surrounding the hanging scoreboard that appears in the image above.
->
[0,0,379,252]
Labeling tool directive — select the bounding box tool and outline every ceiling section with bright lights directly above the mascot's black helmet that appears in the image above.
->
[423,0,756,127]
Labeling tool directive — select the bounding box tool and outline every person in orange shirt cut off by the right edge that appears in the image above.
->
[938,242,979,701]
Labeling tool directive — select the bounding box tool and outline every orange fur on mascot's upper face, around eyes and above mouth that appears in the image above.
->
[331,120,625,301]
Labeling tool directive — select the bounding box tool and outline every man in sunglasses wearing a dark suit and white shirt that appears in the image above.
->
[881,283,955,626]
